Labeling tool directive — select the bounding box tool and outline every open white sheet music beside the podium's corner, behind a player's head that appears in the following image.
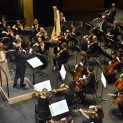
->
[34,80,52,92]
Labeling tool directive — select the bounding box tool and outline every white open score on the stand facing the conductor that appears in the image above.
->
[27,57,43,68]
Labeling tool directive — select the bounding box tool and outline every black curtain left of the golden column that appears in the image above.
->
[0,0,24,20]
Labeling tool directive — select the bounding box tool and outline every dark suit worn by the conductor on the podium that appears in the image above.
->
[14,50,31,86]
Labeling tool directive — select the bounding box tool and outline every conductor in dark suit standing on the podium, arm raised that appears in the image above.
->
[13,44,32,88]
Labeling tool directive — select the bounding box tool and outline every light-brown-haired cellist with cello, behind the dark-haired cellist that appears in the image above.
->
[71,51,88,81]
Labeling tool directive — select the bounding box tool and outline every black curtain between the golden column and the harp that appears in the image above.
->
[33,0,56,26]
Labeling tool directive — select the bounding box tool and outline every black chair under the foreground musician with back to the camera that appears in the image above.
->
[35,110,51,123]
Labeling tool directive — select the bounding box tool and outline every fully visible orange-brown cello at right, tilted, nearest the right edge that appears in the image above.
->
[104,59,120,76]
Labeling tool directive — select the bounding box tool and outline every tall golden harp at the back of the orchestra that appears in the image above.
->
[50,6,61,44]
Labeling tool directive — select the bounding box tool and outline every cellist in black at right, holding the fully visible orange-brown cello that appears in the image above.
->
[104,49,123,83]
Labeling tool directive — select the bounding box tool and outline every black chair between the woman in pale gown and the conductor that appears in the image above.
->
[5,49,16,73]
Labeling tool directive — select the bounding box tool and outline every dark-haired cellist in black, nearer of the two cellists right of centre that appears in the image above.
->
[74,65,95,102]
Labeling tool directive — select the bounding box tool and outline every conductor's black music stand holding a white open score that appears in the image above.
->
[27,57,43,85]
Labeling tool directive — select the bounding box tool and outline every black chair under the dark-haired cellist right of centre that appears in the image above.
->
[84,81,99,103]
